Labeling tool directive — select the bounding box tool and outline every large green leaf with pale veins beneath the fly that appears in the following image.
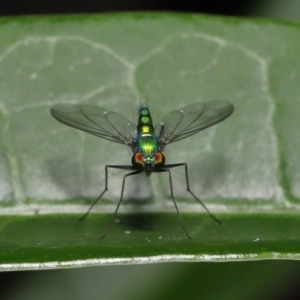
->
[0,13,300,270]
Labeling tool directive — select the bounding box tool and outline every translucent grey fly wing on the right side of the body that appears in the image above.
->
[156,100,234,146]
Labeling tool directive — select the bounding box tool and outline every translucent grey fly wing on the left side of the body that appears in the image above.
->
[51,104,136,147]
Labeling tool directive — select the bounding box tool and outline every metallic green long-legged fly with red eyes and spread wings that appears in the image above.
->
[51,100,234,239]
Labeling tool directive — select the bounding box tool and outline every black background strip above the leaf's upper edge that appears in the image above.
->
[0,0,262,16]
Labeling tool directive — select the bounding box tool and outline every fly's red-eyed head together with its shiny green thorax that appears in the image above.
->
[132,135,165,176]
